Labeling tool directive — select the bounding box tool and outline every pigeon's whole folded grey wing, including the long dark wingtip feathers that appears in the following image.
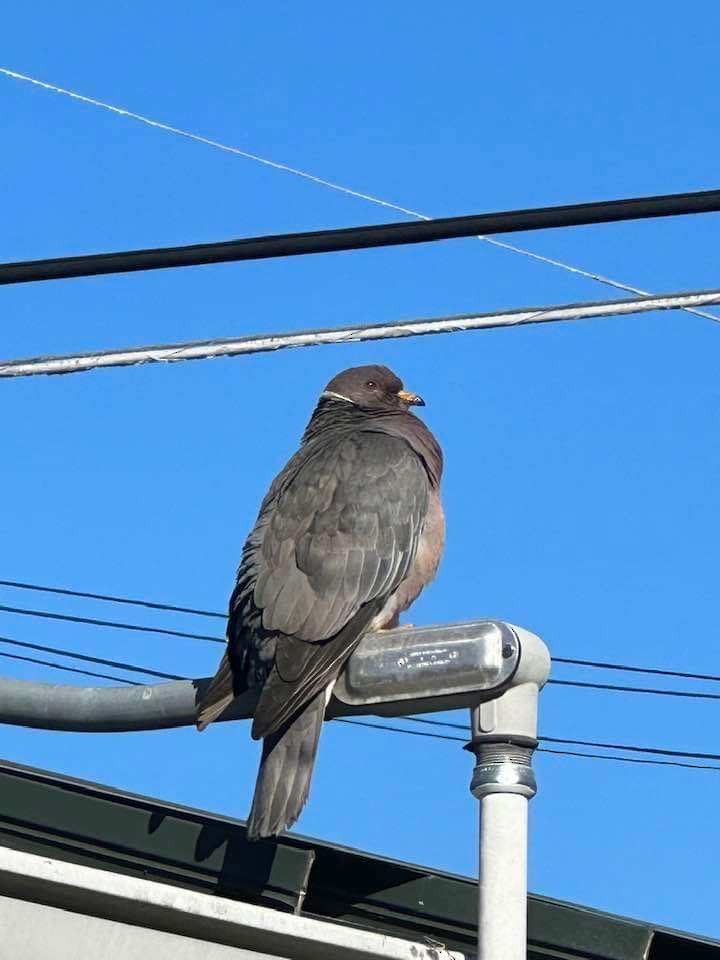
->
[253,432,429,737]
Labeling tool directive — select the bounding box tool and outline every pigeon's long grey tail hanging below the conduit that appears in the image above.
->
[247,690,326,840]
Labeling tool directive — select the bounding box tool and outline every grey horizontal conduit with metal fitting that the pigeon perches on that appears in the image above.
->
[0,620,520,733]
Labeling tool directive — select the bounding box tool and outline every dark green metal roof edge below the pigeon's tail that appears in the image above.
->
[0,762,720,960]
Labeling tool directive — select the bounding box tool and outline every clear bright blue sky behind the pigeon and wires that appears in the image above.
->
[0,0,720,936]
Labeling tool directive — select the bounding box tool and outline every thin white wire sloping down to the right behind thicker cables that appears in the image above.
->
[0,67,720,323]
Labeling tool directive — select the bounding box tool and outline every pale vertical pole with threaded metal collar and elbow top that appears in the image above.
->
[468,627,550,960]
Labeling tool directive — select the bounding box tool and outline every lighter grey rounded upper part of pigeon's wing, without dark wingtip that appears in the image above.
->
[254,433,428,643]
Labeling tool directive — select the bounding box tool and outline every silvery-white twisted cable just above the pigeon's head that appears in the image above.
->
[0,290,720,377]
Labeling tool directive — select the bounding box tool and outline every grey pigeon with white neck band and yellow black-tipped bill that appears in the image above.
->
[196,365,445,840]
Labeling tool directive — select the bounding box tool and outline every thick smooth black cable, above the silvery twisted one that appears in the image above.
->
[0,190,720,284]
